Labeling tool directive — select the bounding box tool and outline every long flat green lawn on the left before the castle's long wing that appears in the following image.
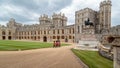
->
[0,40,69,51]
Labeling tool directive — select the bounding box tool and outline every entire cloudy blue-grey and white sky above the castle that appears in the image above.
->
[0,0,120,26]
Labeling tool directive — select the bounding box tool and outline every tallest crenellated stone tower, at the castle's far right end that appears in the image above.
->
[99,0,112,29]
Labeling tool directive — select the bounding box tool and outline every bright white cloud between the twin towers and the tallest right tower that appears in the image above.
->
[60,0,103,24]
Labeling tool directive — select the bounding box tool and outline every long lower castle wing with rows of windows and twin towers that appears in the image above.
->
[0,13,74,42]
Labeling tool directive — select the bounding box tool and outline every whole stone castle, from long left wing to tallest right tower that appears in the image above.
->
[0,0,112,42]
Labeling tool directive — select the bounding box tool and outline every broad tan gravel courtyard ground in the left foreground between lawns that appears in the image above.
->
[0,46,82,68]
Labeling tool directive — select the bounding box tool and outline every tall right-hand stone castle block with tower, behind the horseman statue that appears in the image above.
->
[75,0,111,42]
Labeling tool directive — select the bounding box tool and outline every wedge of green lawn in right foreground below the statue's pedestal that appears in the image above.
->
[72,49,113,68]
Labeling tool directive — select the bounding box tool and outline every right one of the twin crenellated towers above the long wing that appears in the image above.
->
[52,13,67,27]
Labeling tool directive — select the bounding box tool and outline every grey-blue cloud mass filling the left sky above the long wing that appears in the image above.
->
[0,0,72,24]
